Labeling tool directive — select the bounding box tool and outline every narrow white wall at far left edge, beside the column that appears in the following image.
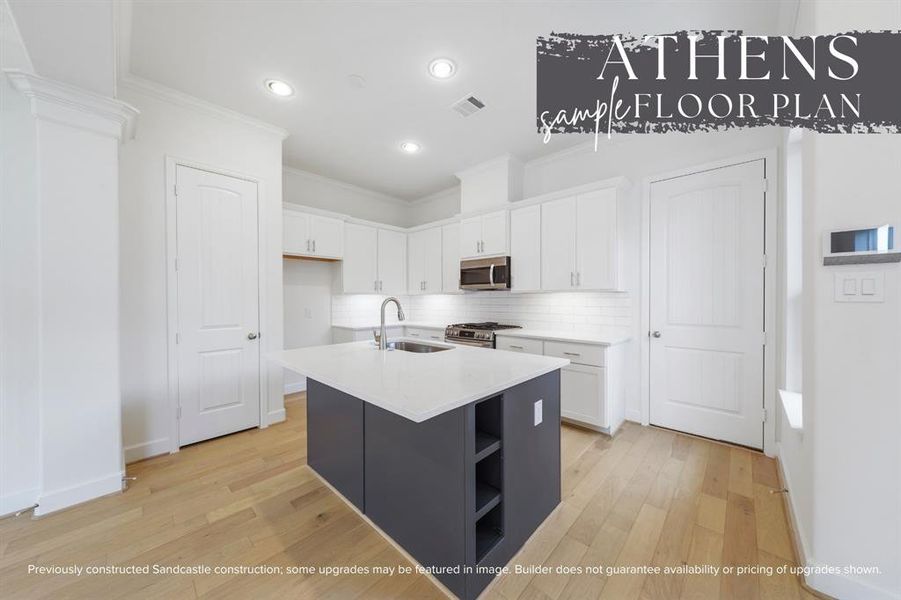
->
[0,3,40,515]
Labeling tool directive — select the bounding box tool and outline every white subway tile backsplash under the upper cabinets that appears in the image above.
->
[332,292,632,331]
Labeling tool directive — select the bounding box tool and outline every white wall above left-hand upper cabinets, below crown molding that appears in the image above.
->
[283,167,412,227]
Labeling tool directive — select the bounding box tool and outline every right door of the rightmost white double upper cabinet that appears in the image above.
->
[576,189,619,290]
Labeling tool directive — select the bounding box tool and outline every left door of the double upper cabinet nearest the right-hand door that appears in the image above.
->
[541,198,576,290]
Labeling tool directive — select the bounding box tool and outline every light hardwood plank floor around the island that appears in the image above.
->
[0,394,811,600]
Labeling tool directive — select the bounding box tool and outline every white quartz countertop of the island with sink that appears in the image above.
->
[268,338,569,423]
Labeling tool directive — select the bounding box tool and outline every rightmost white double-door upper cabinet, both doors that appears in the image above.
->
[540,188,620,291]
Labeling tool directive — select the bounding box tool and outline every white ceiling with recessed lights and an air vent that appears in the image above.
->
[129,0,785,200]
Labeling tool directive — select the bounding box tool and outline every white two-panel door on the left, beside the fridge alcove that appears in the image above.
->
[176,166,260,446]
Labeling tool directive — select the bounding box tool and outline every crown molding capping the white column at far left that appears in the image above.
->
[4,69,140,141]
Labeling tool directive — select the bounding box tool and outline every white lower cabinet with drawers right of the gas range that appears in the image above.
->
[496,334,625,435]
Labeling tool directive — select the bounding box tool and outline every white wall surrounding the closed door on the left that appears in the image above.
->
[120,83,284,461]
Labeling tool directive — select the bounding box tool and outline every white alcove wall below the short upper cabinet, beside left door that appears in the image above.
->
[283,258,338,393]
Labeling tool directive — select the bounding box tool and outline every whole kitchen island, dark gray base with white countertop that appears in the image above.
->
[270,340,569,599]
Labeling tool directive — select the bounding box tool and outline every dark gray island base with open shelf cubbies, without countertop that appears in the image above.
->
[307,370,560,600]
